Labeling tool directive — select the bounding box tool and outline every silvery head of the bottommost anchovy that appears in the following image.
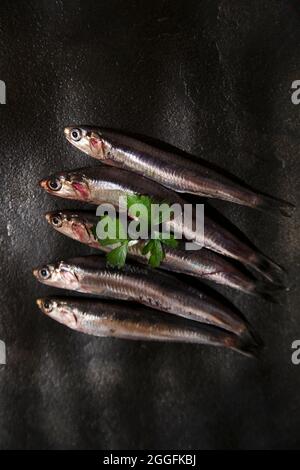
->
[36,298,77,329]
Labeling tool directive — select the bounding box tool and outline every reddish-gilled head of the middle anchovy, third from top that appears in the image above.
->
[45,210,95,245]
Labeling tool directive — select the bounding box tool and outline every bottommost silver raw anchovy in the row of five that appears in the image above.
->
[37,297,256,356]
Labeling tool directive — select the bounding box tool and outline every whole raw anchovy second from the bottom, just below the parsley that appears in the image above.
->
[33,256,258,344]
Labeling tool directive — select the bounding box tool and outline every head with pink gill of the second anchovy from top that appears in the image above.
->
[39,172,90,201]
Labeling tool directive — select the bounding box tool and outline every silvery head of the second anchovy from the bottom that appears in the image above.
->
[33,261,79,290]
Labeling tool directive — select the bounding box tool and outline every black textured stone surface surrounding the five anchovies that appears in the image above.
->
[0,0,300,449]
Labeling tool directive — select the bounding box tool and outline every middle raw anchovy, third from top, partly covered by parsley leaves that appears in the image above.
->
[46,210,278,300]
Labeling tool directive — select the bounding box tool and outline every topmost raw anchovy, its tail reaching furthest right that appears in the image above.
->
[64,126,293,216]
